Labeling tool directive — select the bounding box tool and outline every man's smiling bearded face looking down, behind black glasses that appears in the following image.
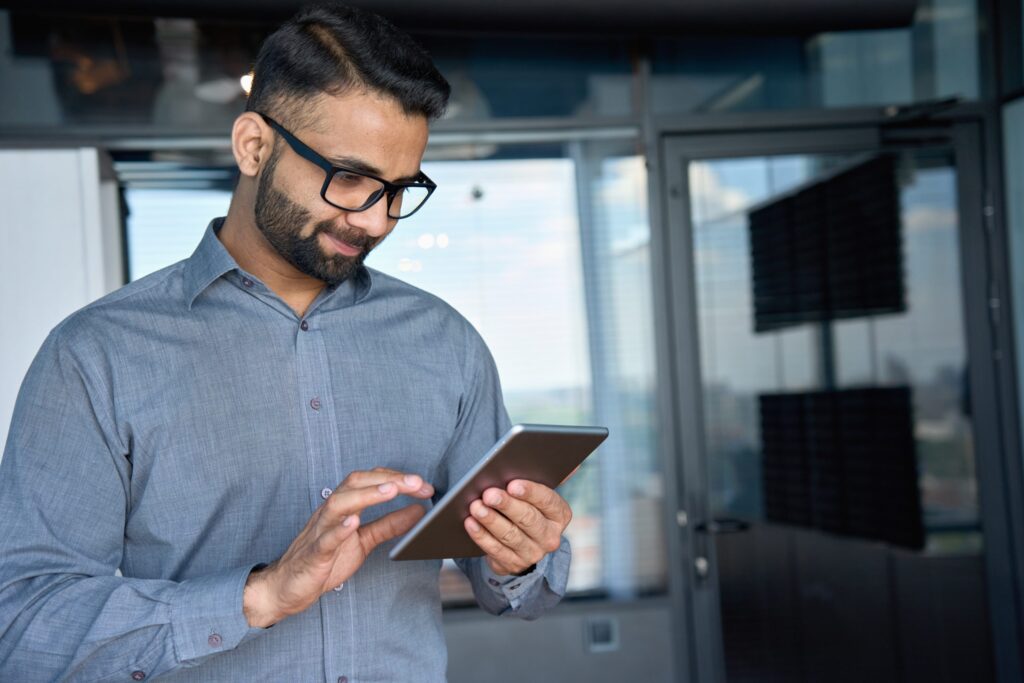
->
[255,92,427,285]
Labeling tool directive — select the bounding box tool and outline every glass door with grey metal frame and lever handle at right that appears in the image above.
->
[665,131,1015,683]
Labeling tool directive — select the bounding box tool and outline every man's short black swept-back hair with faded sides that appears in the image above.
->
[246,2,452,128]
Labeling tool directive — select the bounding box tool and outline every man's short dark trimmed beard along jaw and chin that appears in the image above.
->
[255,150,384,287]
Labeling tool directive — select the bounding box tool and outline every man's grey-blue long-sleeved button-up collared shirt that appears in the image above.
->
[0,219,569,683]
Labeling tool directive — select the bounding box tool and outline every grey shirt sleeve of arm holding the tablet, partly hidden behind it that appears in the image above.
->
[447,324,571,620]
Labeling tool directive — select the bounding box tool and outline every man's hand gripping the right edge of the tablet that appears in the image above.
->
[464,479,572,575]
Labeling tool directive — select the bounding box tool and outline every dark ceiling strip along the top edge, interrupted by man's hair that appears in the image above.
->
[0,0,916,35]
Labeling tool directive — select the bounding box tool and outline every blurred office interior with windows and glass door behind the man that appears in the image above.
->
[0,0,1024,683]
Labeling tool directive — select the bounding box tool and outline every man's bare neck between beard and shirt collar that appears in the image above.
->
[217,211,324,317]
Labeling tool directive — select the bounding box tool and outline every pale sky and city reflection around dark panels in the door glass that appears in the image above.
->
[690,149,980,551]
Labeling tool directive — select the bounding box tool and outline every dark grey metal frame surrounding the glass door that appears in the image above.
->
[647,108,1024,683]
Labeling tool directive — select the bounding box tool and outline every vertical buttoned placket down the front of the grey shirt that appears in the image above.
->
[295,316,354,683]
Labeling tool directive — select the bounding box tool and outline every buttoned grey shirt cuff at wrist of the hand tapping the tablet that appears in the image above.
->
[171,566,266,661]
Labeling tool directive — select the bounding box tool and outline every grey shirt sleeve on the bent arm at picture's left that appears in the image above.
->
[0,324,265,683]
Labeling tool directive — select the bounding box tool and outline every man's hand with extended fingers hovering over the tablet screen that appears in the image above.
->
[242,467,434,628]
